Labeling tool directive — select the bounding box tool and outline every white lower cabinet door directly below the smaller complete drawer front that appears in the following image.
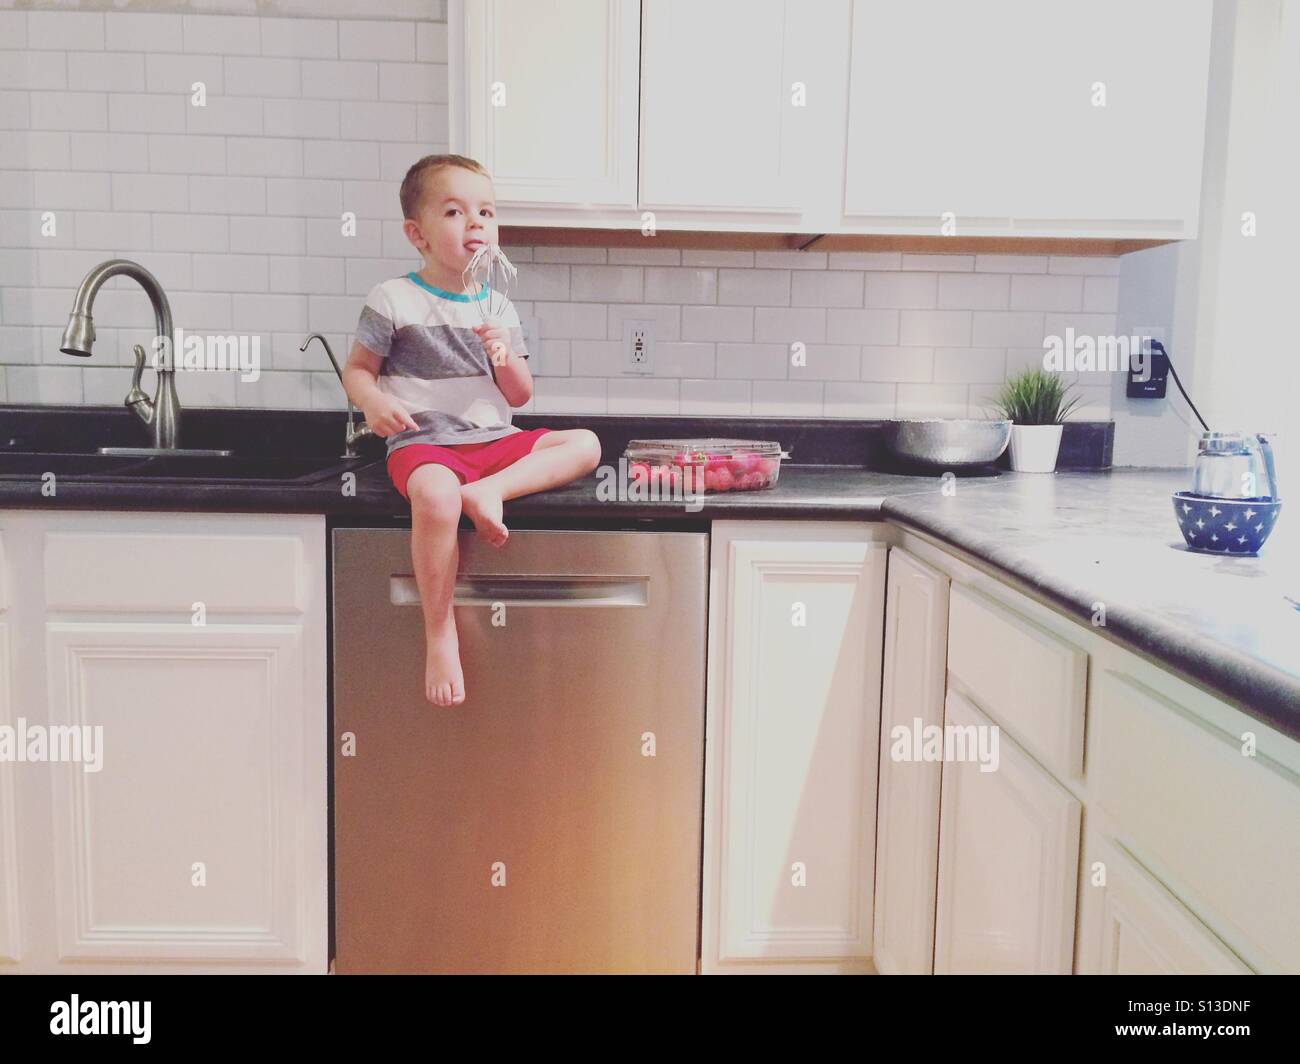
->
[935,691,1082,974]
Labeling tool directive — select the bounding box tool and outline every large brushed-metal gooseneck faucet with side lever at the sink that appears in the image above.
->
[59,259,230,455]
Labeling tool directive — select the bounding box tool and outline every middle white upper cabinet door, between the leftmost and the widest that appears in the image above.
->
[641,0,849,213]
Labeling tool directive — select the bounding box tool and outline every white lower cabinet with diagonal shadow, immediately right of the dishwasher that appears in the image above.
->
[701,522,887,973]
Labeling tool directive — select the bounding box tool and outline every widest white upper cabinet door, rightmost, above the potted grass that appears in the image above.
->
[844,0,1210,238]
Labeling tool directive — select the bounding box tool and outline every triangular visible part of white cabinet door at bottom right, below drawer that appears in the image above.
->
[1079,814,1251,976]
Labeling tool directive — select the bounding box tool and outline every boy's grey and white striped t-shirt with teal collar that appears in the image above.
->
[356,273,528,454]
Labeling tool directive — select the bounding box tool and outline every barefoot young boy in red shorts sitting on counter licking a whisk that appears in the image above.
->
[343,155,601,706]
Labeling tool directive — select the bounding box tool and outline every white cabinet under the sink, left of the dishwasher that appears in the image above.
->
[0,511,329,973]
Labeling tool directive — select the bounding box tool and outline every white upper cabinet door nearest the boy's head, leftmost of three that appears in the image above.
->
[447,0,641,206]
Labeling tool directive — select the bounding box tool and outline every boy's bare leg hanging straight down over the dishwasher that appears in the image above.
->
[407,464,465,705]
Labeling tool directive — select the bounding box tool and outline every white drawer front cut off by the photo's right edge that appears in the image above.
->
[1088,670,1300,972]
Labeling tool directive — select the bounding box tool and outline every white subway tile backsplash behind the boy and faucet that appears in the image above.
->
[0,13,1118,418]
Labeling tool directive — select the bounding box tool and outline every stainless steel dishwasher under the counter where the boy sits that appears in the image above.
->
[333,528,709,973]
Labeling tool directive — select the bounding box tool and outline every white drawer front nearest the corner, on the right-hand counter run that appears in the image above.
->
[948,584,1088,779]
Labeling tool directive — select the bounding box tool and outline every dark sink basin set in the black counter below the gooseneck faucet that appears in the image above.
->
[0,451,373,483]
